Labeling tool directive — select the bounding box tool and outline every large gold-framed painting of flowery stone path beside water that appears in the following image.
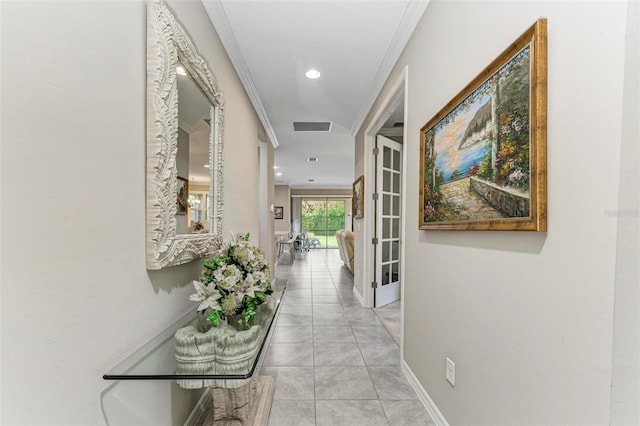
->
[420,20,546,231]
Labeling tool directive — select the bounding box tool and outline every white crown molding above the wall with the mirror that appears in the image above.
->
[202,0,280,148]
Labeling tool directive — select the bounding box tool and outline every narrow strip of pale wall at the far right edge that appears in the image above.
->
[611,1,640,425]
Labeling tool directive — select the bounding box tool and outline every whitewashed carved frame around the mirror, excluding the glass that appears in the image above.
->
[146,0,224,269]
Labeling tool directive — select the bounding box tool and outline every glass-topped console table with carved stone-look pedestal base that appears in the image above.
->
[103,285,285,425]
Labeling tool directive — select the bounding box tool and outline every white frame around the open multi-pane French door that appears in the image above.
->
[362,66,409,308]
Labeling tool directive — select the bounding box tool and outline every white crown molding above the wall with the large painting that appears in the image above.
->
[351,0,430,137]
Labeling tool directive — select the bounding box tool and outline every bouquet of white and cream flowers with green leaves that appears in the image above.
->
[189,234,273,327]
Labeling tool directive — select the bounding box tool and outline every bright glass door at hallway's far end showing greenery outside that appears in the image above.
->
[300,197,345,249]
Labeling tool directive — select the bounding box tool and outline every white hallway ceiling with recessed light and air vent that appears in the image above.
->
[203,0,428,189]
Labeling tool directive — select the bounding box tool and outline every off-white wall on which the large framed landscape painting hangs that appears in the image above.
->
[356,1,638,425]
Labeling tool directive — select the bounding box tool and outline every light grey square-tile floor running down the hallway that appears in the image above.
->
[260,249,435,426]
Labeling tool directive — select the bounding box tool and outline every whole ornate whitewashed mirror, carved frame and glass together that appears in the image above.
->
[147,0,224,269]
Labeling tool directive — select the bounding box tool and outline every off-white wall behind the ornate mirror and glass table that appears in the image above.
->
[0,1,268,425]
